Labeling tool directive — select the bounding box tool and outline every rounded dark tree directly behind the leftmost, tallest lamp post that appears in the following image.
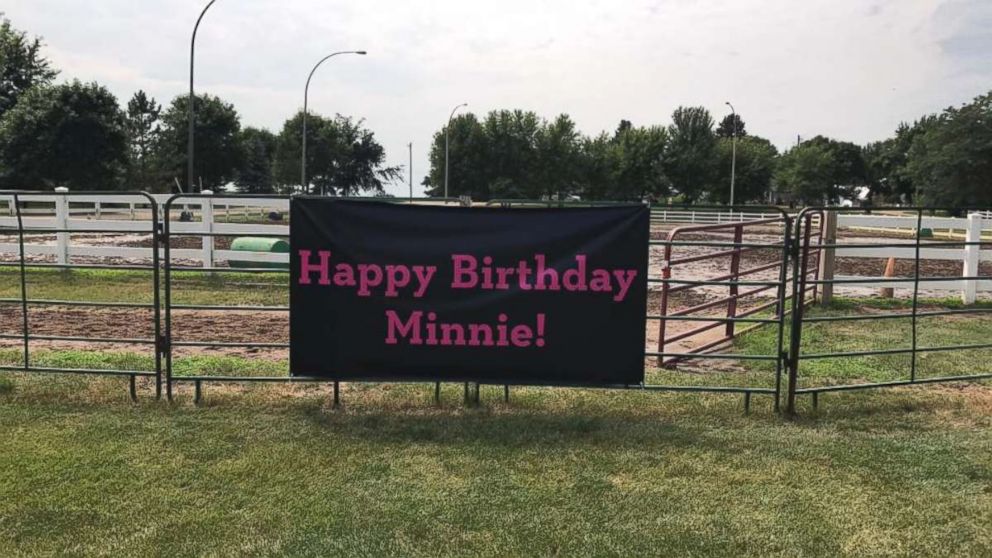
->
[156,95,243,192]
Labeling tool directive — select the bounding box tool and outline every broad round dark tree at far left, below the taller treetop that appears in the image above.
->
[0,81,128,190]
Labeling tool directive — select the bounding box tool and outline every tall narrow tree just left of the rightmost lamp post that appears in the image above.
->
[665,107,716,203]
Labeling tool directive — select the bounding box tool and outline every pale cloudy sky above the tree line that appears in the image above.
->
[0,0,992,197]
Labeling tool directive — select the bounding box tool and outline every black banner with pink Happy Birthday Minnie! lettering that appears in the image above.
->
[290,198,650,385]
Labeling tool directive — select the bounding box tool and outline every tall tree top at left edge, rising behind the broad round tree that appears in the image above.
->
[0,18,58,119]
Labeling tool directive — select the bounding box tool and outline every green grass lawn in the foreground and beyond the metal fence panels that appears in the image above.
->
[0,271,992,556]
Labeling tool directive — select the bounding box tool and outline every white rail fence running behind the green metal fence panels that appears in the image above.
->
[0,193,992,303]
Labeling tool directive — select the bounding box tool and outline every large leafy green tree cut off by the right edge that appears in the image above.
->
[907,92,992,207]
